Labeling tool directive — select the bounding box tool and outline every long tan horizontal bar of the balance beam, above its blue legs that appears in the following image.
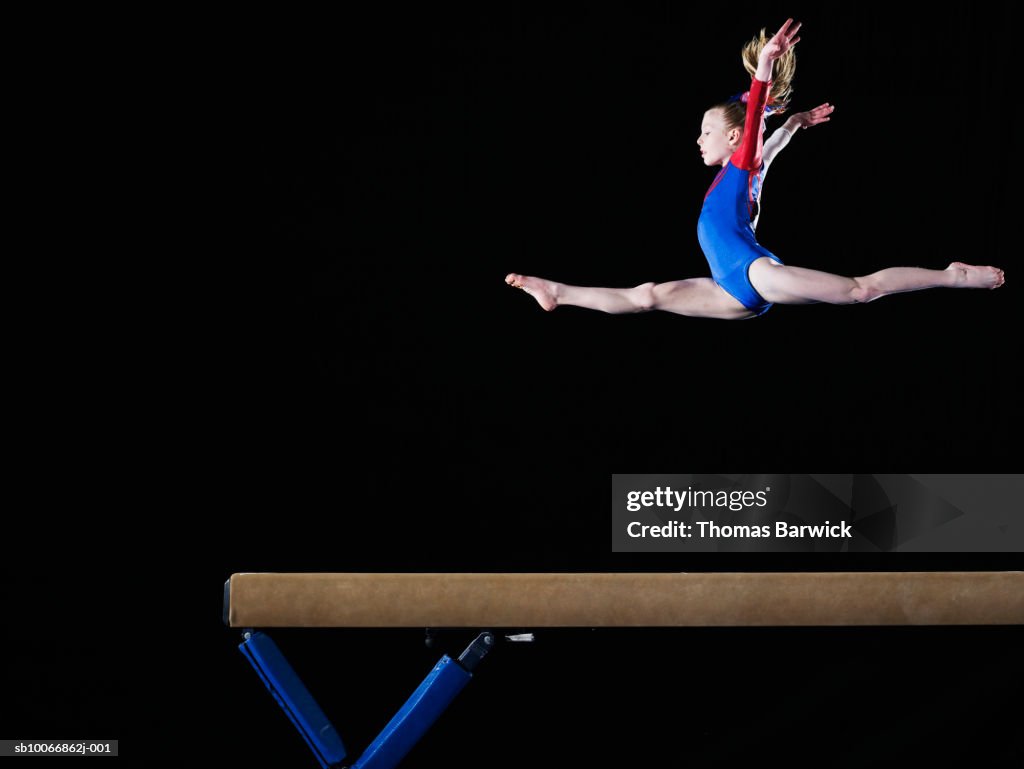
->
[224,571,1024,628]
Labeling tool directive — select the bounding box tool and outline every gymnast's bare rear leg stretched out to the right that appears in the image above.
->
[748,257,1004,304]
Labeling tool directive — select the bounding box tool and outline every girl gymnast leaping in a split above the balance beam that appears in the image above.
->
[505,18,1004,321]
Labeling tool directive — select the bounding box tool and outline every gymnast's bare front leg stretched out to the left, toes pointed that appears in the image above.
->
[505,272,754,319]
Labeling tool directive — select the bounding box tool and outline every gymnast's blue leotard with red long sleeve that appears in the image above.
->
[697,78,782,315]
